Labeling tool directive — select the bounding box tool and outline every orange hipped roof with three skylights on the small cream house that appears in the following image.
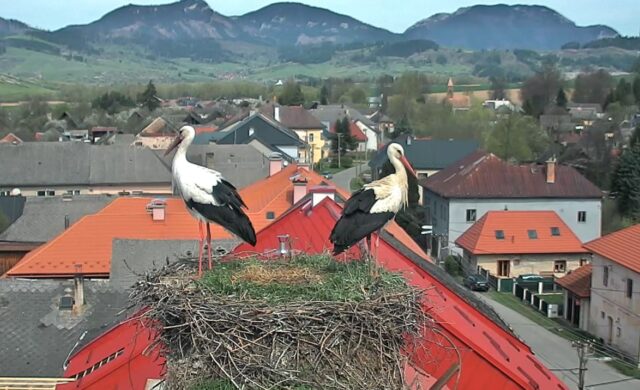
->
[456,211,587,255]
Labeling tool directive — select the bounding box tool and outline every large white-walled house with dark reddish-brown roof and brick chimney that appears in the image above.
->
[420,152,602,256]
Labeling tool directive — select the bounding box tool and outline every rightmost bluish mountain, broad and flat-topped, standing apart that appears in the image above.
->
[404,4,618,50]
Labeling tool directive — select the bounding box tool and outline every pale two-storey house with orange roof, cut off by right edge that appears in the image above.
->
[584,225,640,363]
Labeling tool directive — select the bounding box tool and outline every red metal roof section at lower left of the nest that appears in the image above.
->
[57,315,166,390]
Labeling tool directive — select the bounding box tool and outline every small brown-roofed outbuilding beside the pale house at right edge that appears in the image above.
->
[556,264,593,332]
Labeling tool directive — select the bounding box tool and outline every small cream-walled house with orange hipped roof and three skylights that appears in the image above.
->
[455,211,588,278]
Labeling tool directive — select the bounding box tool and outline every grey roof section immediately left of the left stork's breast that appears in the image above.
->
[89,145,171,185]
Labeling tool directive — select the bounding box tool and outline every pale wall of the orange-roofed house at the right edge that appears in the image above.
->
[589,255,640,361]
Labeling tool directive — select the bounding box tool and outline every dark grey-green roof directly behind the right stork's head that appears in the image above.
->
[369,136,480,170]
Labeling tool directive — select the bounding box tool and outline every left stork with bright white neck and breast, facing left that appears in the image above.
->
[165,126,256,276]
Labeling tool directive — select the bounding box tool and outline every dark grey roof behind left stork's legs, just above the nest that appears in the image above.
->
[109,239,240,290]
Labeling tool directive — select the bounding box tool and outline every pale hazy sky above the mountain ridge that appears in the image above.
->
[0,0,640,35]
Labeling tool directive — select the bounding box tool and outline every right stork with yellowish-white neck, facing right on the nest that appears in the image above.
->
[329,143,415,274]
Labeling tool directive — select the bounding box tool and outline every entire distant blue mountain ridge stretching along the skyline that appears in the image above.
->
[0,0,618,54]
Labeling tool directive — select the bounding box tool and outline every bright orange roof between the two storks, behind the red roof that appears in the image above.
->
[240,164,429,259]
